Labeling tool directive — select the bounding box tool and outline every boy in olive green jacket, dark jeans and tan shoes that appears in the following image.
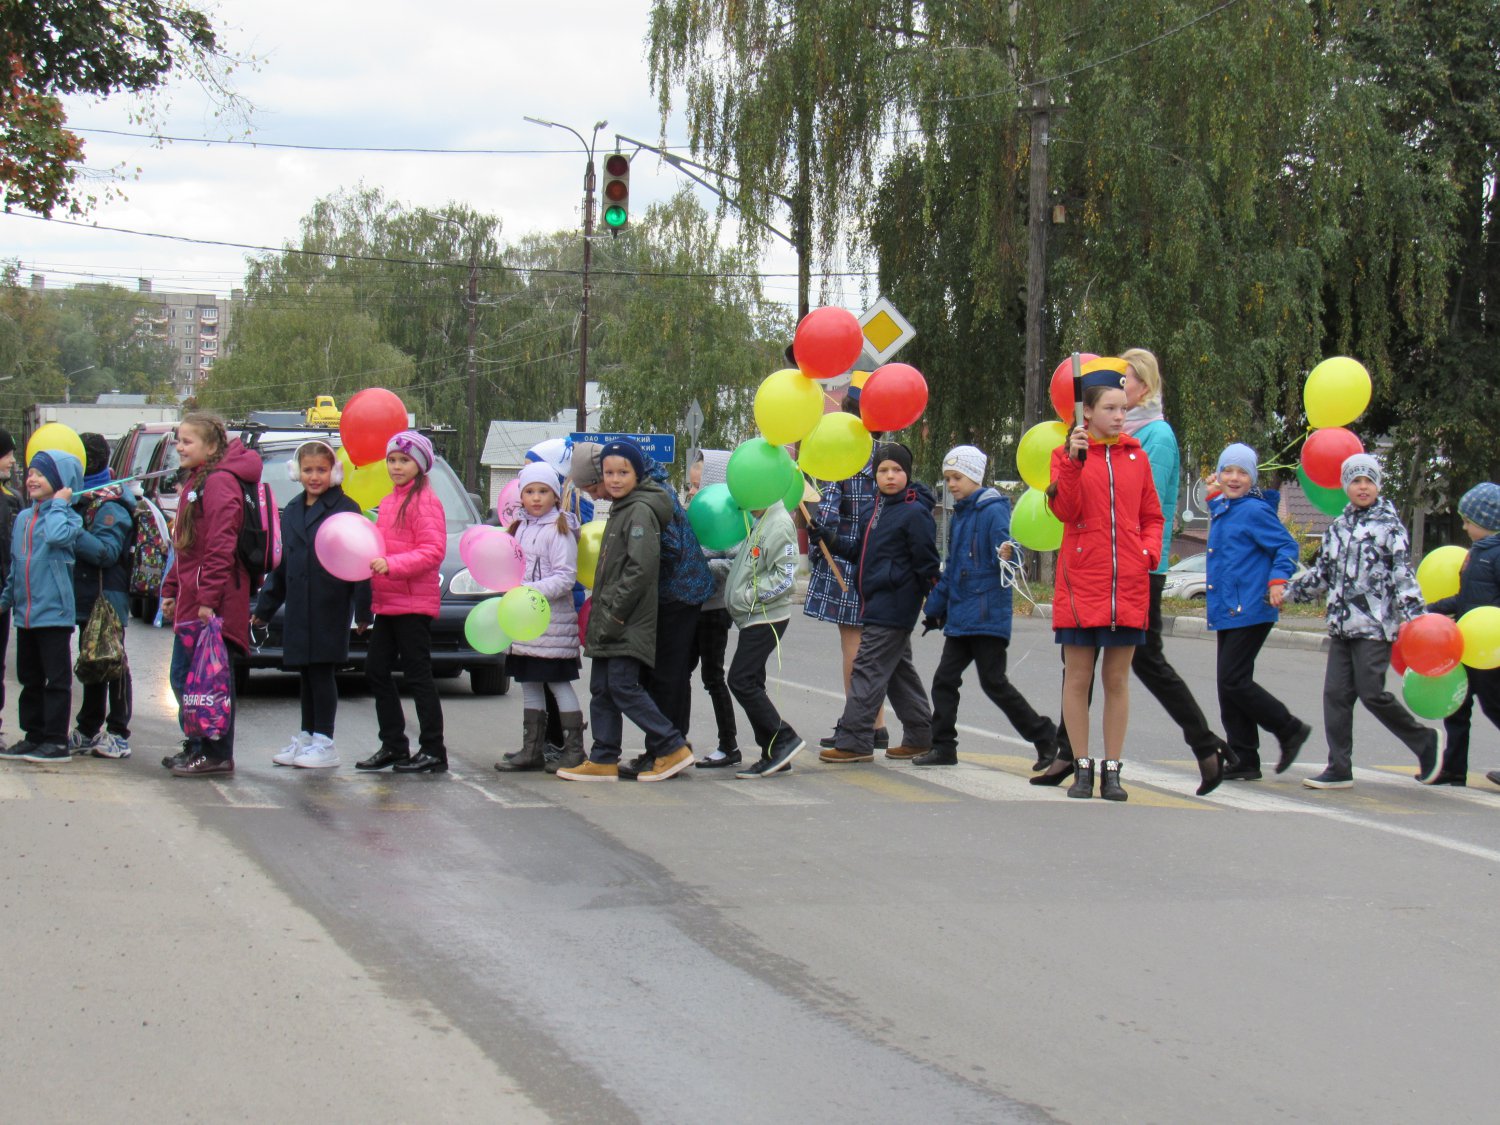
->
[557,440,693,782]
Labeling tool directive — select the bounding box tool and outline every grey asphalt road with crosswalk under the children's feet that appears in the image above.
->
[0,617,1500,1122]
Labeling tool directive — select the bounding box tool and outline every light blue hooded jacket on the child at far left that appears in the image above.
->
[0,450,84,629]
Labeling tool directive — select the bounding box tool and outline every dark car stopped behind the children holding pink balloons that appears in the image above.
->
[236,431,510,696]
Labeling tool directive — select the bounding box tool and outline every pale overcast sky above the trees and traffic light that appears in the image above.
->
[0,0,834,313]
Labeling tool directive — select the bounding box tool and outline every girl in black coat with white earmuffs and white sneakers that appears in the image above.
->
[251,440,371,770]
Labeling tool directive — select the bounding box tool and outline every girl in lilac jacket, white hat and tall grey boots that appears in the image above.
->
[495,461,584,773]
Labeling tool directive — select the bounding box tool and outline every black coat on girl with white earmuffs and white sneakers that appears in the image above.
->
[255,485,371,668]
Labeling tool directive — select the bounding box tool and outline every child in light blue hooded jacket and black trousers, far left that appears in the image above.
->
[0,450,83,762]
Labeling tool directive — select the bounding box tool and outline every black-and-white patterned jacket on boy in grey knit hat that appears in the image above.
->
[1287,497,1427,641]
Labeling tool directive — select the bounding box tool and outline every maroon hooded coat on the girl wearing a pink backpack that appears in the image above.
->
[162,438,263,653]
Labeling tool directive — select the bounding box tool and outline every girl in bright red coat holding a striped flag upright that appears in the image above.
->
[1047,367,1163,801]
